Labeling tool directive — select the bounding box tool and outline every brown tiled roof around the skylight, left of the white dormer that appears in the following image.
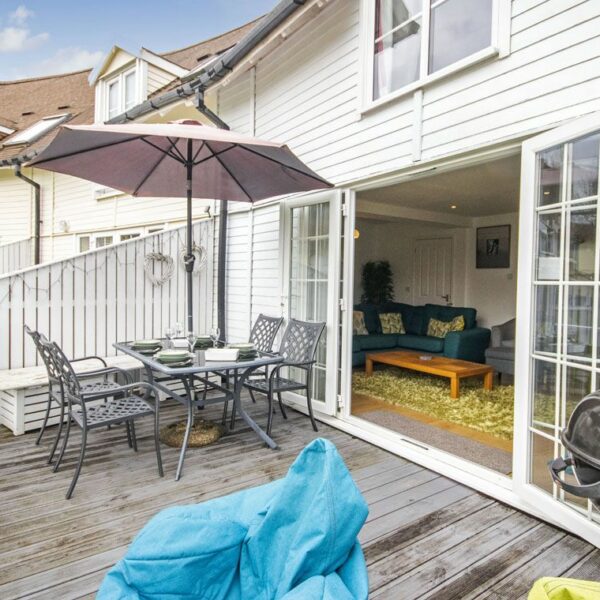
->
[0,70,94,161]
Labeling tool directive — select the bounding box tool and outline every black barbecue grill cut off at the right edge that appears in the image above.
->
[550,392,600,509]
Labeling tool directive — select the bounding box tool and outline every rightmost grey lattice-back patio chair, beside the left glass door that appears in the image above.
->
[239,319,325,435]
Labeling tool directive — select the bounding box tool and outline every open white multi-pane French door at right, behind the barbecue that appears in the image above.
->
[514,113,600,545]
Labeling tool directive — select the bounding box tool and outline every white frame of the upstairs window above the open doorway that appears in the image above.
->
[359,0,511,113]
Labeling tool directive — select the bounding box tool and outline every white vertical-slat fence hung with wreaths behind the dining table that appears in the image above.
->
[0,220,213,369]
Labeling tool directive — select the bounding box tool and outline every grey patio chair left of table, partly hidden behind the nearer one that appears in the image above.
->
[23,325,131,464]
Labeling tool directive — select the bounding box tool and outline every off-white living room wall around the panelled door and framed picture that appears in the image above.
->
[354,213,518,327]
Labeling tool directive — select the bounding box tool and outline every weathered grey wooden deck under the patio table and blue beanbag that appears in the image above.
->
[0,396,600,600]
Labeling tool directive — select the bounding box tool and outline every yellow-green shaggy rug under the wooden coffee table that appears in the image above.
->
[352,367,515,440]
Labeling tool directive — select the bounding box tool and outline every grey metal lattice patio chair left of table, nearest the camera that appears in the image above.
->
[40,337,163,500]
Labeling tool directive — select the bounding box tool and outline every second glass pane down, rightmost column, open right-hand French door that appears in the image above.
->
[569,209,596,281]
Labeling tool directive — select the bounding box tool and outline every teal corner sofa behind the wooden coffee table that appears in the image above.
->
[352,302,490,367]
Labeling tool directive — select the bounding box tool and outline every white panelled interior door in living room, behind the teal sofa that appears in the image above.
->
[413,238,452,306]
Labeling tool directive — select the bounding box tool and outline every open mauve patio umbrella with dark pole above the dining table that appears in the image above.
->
[27,120,331,331]
